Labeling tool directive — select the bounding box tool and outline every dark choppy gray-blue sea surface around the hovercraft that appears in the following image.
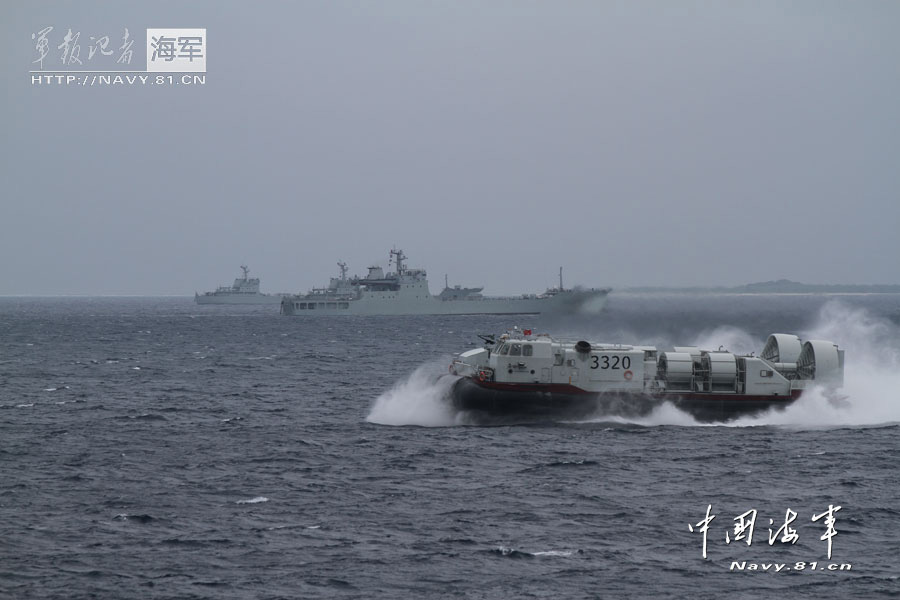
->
[0,294,900,599]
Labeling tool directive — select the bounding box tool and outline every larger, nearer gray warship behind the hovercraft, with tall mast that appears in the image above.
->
[281,250,610,317]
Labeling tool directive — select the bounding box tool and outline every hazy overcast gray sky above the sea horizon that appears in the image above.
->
[0,0,900,294]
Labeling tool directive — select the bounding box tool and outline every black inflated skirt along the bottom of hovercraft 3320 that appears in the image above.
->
[451,377,801,424]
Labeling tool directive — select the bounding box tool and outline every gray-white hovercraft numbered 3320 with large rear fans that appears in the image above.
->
[450,328,844,423]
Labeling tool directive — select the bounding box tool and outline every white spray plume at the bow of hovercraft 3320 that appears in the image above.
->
[366,358,457,427]
